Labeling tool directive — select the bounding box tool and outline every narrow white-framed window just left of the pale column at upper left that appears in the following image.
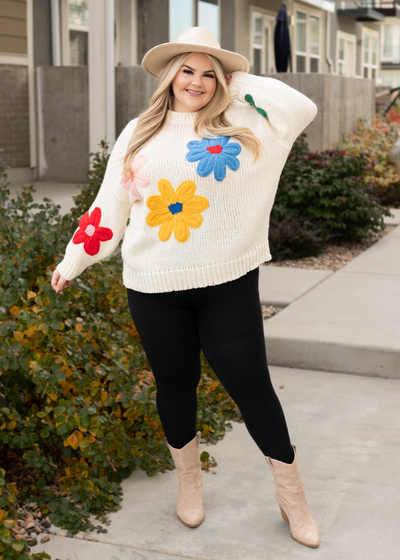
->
[68,0,89,66]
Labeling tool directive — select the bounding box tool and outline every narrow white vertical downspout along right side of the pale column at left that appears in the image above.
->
[105,0,115,150]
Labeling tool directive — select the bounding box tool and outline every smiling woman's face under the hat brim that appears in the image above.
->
[172,53,217,112]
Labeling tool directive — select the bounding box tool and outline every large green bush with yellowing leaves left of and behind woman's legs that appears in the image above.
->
[0,143,240,558]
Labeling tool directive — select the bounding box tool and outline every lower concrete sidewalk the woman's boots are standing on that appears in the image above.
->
[32,367,400,560]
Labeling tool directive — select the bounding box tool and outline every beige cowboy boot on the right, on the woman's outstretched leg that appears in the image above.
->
[265,445,320,548]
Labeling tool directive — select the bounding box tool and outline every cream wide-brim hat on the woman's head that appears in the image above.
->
[142,27,250,78]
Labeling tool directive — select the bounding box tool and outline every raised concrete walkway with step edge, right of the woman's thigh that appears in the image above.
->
[264,226,400,379]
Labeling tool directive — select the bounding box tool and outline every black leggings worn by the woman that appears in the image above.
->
[127,268,294,463]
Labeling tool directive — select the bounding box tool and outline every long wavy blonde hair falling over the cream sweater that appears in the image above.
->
[123,52,261,174]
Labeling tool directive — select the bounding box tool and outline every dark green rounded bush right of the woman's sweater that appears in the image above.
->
[270,133,390,260]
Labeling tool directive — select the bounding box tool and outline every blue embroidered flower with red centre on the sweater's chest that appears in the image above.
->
[186,136,242,181]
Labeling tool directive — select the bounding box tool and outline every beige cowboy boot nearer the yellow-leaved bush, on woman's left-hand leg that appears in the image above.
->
[164,431,205,527]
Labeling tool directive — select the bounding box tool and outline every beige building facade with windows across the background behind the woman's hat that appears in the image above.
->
[0,0,392,181]
